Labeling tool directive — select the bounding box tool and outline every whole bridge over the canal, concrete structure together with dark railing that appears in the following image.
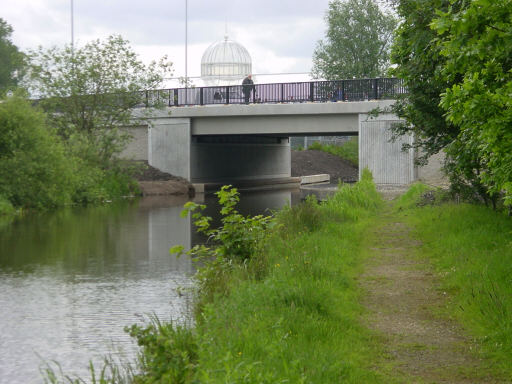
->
[124,79,440,188]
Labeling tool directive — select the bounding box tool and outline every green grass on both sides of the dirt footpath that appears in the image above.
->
[41,178,512,384]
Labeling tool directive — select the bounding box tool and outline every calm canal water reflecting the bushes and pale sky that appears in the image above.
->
[0,191,297,384]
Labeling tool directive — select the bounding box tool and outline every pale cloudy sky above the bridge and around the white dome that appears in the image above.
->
[0,0,329,84]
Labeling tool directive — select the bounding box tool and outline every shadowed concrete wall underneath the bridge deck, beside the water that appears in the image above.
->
[190,137,291,182]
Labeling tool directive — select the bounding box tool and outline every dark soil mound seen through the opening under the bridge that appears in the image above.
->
[291,149,359,184]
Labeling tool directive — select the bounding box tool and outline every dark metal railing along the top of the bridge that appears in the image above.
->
[141,78,406,107]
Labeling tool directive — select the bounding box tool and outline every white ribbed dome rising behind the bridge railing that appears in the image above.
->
[201,36,252,83]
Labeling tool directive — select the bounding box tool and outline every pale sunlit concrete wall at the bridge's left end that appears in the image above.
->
[148,119,191,180]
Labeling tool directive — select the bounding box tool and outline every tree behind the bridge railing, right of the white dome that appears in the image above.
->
[312,0,397,80]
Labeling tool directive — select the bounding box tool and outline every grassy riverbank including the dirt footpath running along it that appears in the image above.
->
[122,180,512,383]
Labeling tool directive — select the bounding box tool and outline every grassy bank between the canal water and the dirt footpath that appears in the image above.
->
[124,172,390,383]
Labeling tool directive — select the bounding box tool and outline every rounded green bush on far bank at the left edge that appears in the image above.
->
[0,96,74,208]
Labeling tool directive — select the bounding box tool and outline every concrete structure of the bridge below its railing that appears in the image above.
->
[123,82,440,185]
